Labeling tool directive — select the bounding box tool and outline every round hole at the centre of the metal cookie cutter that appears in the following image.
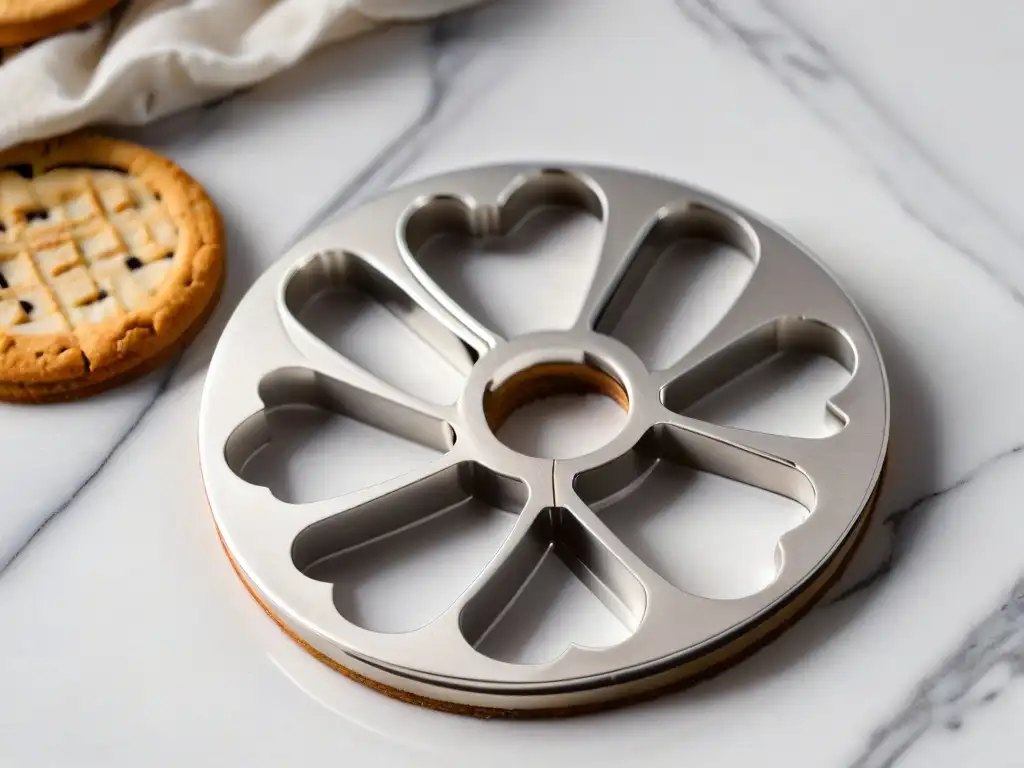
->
[483,362,630,459]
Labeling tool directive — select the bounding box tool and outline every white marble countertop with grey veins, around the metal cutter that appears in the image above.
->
[0,0,1024,768]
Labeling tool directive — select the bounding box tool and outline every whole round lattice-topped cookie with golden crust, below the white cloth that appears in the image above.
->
[0,134,223,402]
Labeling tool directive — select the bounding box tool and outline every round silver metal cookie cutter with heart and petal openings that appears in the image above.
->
[200,166,889,714]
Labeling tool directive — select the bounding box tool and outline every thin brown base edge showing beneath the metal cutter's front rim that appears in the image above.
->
[214,458,888,720]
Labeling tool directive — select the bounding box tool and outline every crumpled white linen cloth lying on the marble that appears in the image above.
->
[0,0,479,147]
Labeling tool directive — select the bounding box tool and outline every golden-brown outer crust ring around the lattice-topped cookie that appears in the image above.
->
[0,134,223,402]
